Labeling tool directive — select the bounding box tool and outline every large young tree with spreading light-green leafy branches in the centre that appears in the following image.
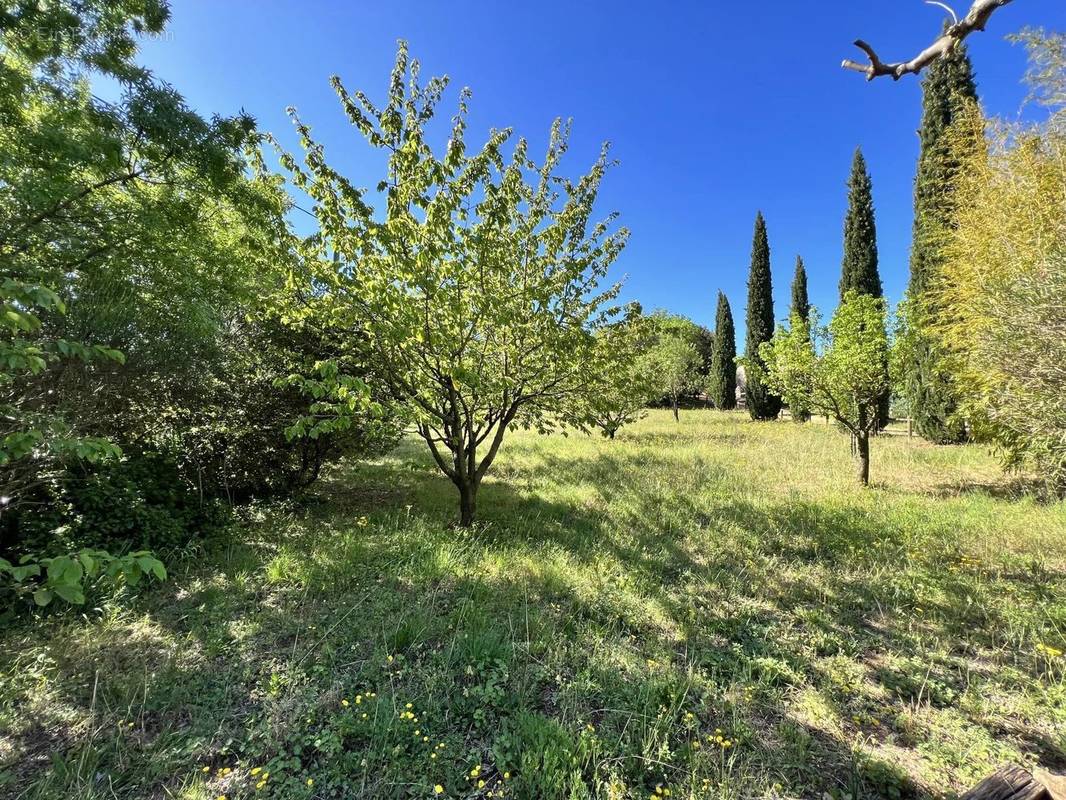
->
[281,43,628,526]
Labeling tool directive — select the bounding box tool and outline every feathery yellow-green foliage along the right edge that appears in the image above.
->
[928,93,1066,492]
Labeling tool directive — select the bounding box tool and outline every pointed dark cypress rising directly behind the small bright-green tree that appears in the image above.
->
[840,147,892,428]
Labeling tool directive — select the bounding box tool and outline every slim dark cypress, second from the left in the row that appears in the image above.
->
[744,211,781,419]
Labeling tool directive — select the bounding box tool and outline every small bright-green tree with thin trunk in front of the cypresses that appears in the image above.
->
[759,291,888,485]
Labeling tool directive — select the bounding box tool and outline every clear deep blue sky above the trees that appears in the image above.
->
[142,0,1066,339]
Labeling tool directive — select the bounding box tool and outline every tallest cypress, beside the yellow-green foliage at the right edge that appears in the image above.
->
[904,43,978,444]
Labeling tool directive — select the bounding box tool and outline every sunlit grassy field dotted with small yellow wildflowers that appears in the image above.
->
[0,411,1066,800]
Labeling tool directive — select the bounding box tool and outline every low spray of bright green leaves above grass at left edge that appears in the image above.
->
[0,548,166,607]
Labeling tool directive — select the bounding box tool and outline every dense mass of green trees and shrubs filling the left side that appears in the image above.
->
[0,0,399,563]
